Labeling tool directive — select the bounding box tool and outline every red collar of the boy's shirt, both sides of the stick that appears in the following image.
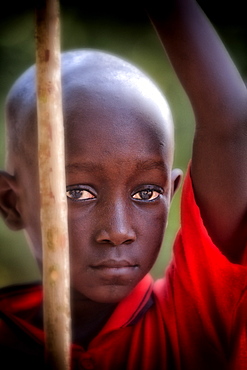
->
[0,274,153,343]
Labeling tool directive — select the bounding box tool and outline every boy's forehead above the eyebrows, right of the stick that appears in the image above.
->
[64,76,173,166]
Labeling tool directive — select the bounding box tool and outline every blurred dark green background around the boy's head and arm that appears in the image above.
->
[0,0,247,287]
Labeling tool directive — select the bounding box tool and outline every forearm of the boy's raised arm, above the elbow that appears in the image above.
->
[147,0,246,134]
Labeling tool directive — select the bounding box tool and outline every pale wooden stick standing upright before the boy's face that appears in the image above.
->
[36,0,70,370]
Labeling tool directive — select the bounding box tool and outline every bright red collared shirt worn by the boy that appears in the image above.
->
[0,172,247,370]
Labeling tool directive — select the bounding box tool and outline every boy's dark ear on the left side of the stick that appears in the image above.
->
[0,171,24,230]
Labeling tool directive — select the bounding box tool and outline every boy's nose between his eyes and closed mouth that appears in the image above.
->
[96,202,136,246]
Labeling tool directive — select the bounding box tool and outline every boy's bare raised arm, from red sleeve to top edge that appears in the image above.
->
[147,0,247,262]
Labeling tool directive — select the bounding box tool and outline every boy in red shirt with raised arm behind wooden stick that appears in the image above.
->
[0,0,247,370]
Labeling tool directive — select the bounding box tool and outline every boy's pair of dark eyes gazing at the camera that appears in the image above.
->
[66,186,163,202]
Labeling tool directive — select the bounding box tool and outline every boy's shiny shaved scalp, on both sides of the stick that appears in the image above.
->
[6,50,173,172]
